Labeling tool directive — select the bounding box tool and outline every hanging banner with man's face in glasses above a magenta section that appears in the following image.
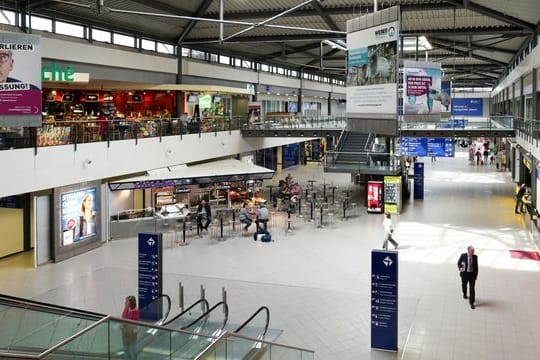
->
[0,32,41,127]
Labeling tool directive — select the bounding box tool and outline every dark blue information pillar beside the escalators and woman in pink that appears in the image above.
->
[139,233,163,321]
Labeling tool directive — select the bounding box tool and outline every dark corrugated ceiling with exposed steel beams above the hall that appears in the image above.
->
[4,0,540,87]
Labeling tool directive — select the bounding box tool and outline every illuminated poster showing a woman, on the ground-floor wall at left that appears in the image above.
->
[60,187,97,246]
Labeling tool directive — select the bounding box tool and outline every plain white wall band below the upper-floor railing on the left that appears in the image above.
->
[0,131,305,197]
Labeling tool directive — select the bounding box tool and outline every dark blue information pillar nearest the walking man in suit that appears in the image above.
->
[371,250,398,351]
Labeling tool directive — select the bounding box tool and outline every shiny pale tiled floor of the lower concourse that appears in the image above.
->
[0,150,540,360]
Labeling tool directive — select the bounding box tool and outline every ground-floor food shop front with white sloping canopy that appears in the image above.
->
[108,159,274,239]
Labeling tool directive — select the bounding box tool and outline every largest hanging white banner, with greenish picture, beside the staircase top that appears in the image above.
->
[346,19,399,119]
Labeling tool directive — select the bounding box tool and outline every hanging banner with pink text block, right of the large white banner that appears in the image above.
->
[403,61,442,121]
